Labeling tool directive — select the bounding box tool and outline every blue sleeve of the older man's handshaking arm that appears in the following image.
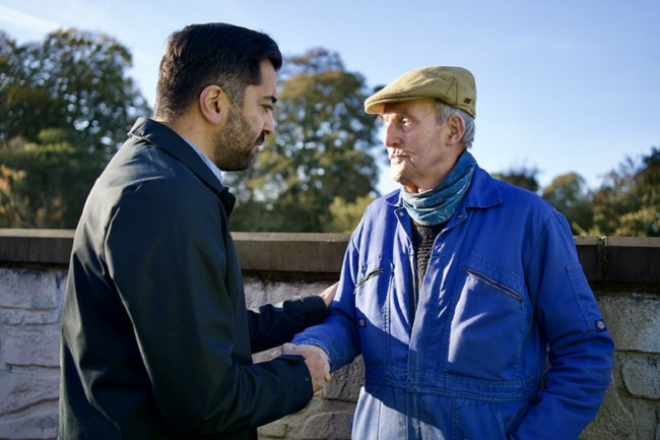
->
[293,230,361,372]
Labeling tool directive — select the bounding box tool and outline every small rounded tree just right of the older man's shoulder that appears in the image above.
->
[543,173,593,234]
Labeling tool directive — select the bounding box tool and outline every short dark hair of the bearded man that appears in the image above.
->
[154,23,282,120]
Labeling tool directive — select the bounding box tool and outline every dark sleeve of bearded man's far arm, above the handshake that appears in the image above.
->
[248,295,328,353]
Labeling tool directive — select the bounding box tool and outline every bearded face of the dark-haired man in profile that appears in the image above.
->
[214,60,277,171]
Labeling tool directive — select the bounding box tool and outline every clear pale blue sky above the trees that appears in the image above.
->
[0,0,660,191]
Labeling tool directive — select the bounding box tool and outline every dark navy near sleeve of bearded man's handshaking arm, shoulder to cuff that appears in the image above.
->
[105,180,312,436]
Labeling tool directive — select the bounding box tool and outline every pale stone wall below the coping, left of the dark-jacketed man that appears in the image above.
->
[0,267,66,439]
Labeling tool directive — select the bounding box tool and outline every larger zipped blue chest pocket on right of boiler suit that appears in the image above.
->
[446,255,532,380]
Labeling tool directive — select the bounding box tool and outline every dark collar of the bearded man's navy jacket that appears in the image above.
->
[128,118,236,213]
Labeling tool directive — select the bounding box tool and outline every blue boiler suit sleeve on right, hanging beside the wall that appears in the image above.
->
[511,212,614,440]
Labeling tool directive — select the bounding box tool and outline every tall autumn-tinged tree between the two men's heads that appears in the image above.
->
[227,49,378,232]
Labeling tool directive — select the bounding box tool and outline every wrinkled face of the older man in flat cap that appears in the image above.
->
[381,99,460,192]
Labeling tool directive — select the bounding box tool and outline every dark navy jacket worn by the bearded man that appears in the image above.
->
[59,119,327,440]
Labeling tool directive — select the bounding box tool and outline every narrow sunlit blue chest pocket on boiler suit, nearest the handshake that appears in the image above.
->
[354,256,394,364]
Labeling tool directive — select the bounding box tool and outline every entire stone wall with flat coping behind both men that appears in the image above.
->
[0,230,660,440]
